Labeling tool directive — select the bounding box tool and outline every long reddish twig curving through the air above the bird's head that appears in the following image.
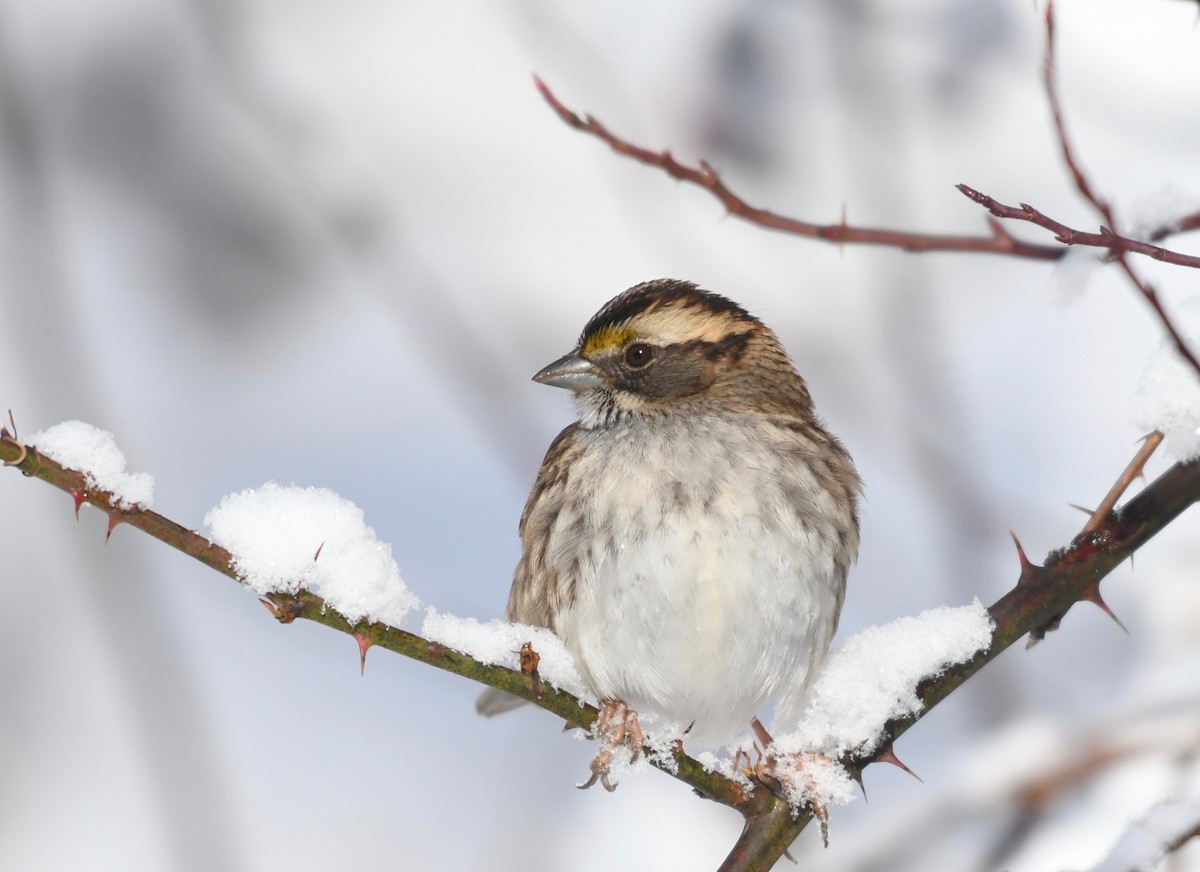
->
[534,76,1064,260]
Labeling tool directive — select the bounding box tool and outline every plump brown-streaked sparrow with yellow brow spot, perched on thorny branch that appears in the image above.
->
[476,278,863,789]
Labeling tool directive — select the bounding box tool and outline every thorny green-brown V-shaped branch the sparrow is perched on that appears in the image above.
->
[0,428,1200,872]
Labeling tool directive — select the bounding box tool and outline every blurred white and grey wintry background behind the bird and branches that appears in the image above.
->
[0,0,1200,872]
